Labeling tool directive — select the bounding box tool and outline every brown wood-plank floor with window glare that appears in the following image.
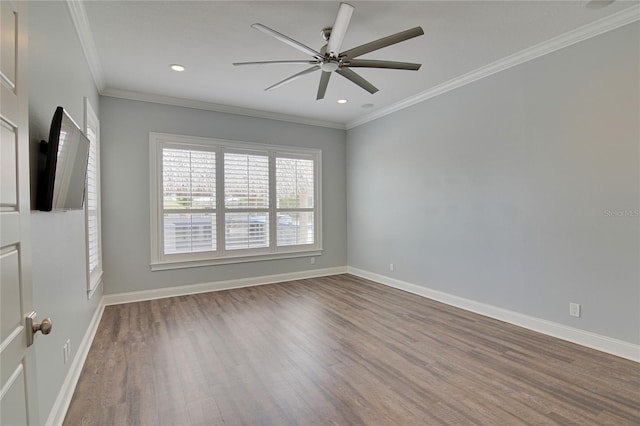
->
[64,275,640,425]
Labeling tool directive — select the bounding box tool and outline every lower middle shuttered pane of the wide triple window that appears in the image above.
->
[225,212,269,250]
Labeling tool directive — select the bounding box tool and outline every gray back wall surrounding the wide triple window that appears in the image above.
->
[100,96,347,293]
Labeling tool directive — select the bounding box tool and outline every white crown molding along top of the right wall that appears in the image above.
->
[346,4,640,130]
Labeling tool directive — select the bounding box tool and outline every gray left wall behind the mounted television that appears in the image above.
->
[28,2,101,424]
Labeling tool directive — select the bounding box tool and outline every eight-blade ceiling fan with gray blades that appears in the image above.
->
[233,3,424,100]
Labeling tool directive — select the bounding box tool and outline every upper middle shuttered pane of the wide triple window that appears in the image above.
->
[224,153,269,209]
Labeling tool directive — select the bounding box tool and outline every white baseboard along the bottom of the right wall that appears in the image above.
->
[347,267,640,362]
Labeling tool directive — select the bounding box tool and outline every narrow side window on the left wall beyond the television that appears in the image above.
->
[84,98,102,298]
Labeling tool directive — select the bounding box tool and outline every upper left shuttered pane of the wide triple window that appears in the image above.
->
[162,149,216,209]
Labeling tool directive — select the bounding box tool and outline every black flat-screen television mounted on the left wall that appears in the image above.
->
[36,107,89,211]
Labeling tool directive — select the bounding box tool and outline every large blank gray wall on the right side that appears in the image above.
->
[347,23,640,344]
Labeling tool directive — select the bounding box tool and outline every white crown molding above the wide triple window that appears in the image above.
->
[100,88,345,130]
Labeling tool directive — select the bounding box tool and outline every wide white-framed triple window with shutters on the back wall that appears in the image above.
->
[149,133,322,270]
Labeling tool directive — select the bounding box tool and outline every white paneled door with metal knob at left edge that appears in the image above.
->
[0,0,39,426]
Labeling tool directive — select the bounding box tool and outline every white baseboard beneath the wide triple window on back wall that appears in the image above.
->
[104,266,347,306]
